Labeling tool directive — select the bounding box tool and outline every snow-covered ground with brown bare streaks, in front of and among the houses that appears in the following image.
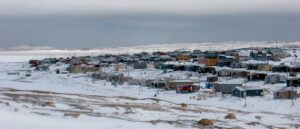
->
[0,41,300,129]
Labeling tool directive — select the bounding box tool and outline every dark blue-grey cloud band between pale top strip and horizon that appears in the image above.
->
[0,14,300,48]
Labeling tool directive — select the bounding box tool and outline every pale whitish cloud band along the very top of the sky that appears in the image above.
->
[0,0,300,15]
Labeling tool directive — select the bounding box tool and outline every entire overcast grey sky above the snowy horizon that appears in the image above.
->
[0,0,300,48]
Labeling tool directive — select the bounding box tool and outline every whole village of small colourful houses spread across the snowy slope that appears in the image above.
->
[29,48,300,99]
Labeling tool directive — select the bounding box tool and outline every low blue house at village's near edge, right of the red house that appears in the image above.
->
[232,87,264,98]
